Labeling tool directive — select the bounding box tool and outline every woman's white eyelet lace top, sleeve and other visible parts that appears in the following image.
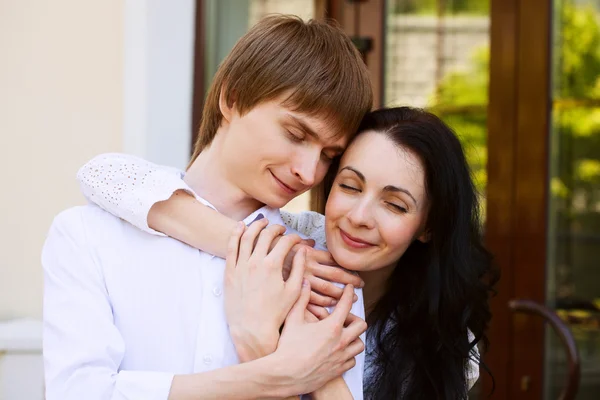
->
[77,153,479,389]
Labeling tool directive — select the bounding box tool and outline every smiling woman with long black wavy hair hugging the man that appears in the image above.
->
[79,107,497,399]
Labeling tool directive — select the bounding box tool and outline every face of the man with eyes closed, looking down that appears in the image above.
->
[219,98,349,208]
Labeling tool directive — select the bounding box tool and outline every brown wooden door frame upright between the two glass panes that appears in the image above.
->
[483,0,552,400]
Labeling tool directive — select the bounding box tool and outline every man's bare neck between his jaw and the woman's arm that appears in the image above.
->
[184,138,263,220]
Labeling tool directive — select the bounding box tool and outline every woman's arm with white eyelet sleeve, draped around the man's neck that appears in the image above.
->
[77,153,236,258]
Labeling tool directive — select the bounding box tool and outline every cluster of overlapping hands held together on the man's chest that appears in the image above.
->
[225,219,366,393]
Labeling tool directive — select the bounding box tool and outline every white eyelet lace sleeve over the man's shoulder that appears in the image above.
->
[77,153,194,236]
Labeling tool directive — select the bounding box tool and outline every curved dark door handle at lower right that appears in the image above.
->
[508,299,581,400]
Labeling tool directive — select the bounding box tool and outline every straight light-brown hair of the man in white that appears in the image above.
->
[192,15,373,161]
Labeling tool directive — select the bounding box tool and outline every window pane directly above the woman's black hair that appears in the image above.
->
[384,0,490,225]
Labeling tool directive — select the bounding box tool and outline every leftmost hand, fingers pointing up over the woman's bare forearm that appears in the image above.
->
[225,220,305,362]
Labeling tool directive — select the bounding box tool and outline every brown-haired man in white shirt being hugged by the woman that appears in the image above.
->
[42,16,372,400]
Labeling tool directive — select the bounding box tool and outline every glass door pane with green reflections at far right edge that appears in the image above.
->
[544,0,600,400]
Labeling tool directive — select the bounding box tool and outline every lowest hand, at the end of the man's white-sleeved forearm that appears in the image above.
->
[269,280,367,394]
